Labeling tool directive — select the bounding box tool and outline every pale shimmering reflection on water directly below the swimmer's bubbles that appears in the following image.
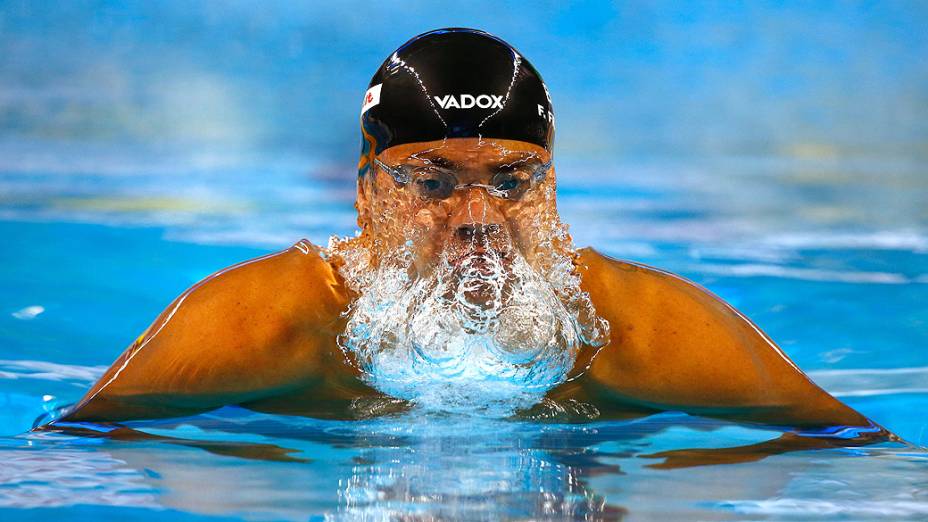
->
[339,412,624,520]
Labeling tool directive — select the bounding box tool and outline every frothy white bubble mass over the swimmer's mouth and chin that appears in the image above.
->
[330,230,604,416]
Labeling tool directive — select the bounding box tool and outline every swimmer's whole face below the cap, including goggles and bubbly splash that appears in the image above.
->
[338,138,608,407]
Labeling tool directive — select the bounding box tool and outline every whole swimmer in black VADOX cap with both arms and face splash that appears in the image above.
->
[54,29,888,459]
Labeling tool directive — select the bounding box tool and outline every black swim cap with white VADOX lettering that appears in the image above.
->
[359,28,554,175]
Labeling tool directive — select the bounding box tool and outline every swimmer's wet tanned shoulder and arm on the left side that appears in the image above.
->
[58,241,346,422]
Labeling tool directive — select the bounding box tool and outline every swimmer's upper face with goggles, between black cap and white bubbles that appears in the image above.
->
[358,138,556,274]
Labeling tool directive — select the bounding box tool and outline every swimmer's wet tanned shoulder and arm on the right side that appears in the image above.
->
[580,249,873,427]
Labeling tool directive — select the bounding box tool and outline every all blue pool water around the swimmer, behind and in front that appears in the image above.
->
[0,1,928,520]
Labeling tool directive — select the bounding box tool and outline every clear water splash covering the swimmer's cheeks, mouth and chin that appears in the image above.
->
[326,158,609,416]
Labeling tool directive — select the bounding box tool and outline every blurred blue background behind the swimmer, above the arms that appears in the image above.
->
[0,0,928,438]
